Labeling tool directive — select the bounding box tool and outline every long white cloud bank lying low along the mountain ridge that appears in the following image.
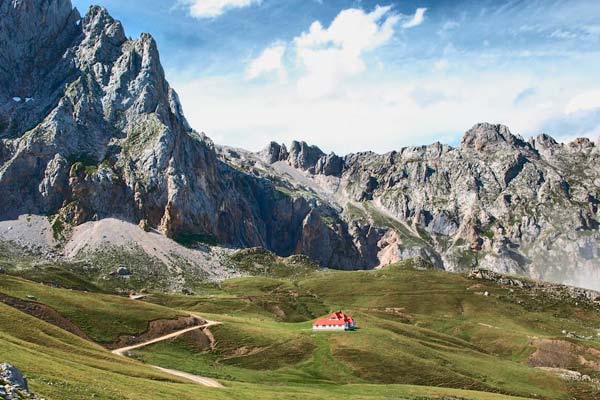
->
[173,71,562,154]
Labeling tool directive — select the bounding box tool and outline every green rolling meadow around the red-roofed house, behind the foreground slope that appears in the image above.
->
[136,264,600,399]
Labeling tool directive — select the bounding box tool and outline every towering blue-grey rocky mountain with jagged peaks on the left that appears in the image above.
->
[0,0,352,262]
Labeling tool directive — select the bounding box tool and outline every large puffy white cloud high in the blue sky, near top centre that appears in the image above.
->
[294,6,400,98]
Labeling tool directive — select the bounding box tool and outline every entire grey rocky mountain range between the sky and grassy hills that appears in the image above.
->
[0,0,600,287]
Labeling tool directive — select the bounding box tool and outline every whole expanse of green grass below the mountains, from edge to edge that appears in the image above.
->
[0,255,600,400]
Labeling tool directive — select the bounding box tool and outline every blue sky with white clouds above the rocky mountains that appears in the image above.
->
[73,0,600,154]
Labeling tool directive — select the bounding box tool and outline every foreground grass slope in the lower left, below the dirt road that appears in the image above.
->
[0,294,528,400]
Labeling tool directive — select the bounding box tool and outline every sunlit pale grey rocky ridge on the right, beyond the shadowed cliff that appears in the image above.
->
[261,123,600,286]
